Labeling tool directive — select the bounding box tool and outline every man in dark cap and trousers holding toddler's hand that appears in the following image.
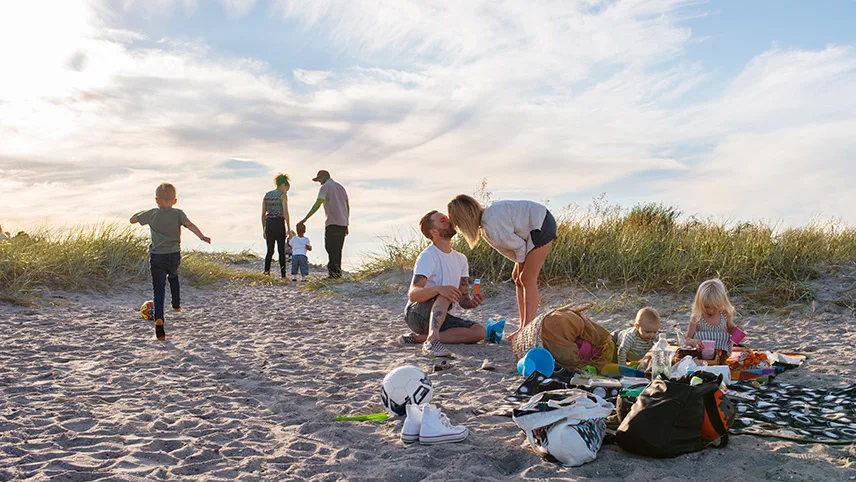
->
[297,169,351,278]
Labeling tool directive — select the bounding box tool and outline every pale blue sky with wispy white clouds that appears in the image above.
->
[0,0,856,267]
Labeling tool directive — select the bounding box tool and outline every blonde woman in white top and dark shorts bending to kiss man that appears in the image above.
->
[447,194,556,339]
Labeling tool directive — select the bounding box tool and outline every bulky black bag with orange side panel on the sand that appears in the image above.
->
[616,372,728,458]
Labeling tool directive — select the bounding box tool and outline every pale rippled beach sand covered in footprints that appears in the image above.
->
[0,267,856,481]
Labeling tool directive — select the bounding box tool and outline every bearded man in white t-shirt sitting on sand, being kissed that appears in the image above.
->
[398,211,485,356]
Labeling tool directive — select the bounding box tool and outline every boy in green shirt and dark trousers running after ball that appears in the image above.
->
[131,182,211,340]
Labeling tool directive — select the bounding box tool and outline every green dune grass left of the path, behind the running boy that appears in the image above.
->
[0,224,279,303]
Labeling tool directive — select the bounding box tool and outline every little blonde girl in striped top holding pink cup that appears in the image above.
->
[686,279,736,364]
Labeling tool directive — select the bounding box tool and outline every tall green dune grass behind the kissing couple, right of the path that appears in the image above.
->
[360,199,856,303]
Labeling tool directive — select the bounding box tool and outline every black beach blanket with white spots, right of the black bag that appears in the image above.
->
[729,382,856,444]
